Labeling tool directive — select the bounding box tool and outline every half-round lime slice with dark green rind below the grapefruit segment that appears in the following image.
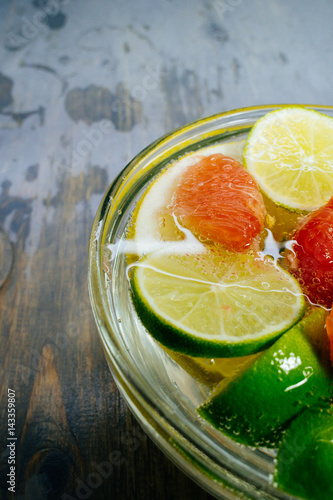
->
[131,247,304,357]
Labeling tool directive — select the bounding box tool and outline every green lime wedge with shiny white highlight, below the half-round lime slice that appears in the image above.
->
[198,308,333,447]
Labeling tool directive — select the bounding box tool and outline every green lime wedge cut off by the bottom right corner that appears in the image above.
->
[274,408,333,500]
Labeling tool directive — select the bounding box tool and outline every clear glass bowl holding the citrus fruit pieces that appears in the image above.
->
[89,105,333,500]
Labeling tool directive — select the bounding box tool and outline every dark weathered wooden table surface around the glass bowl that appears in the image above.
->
[0,0,333,500]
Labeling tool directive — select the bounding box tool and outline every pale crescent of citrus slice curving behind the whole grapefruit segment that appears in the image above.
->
[129,140,245,257]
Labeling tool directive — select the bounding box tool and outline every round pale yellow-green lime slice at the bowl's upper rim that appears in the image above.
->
[243,106,333,211]
